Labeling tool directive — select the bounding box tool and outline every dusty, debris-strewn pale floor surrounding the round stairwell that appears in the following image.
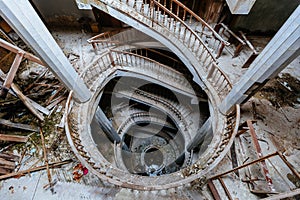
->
[0,30,300,200]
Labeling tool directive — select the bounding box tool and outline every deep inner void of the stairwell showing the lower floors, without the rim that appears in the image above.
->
[91,56,211,177]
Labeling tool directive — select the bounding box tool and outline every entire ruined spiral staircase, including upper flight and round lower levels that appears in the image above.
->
[66,0,239,190]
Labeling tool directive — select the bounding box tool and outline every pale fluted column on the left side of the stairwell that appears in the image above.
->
[0,0,91,102]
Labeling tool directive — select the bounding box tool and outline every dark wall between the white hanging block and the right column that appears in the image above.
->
[231,0,300,34]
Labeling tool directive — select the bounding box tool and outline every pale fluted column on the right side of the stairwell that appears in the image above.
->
[219,6,300,114]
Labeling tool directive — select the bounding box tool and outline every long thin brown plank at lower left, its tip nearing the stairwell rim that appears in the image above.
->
[0,159,72,180]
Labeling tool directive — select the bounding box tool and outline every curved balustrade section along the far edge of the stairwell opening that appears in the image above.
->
[80,50,196,97]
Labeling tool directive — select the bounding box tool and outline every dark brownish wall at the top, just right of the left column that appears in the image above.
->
[30,0,95,27]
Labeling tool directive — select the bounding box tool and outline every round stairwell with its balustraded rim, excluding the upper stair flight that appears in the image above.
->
[67,36,235,190]
